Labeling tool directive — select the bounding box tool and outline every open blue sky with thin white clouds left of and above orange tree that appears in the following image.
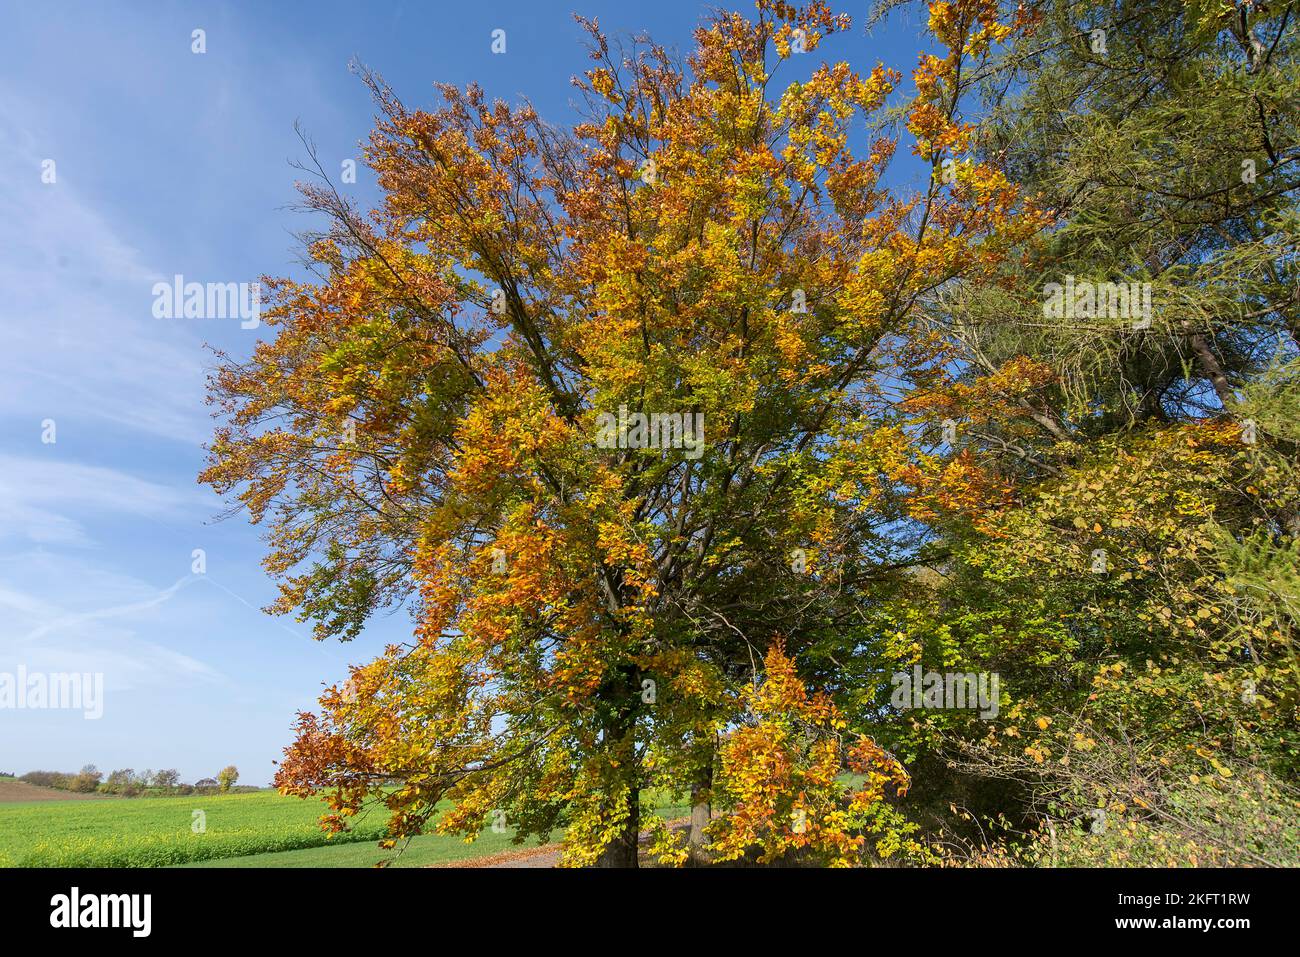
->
[0,0,920,784]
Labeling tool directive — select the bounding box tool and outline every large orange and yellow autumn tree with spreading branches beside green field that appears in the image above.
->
[203,0,1044,866]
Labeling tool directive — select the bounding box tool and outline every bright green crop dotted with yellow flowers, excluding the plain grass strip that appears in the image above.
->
[0,791,384,867]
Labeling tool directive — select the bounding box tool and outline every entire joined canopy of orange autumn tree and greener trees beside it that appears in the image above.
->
[202,0,1300,866]
